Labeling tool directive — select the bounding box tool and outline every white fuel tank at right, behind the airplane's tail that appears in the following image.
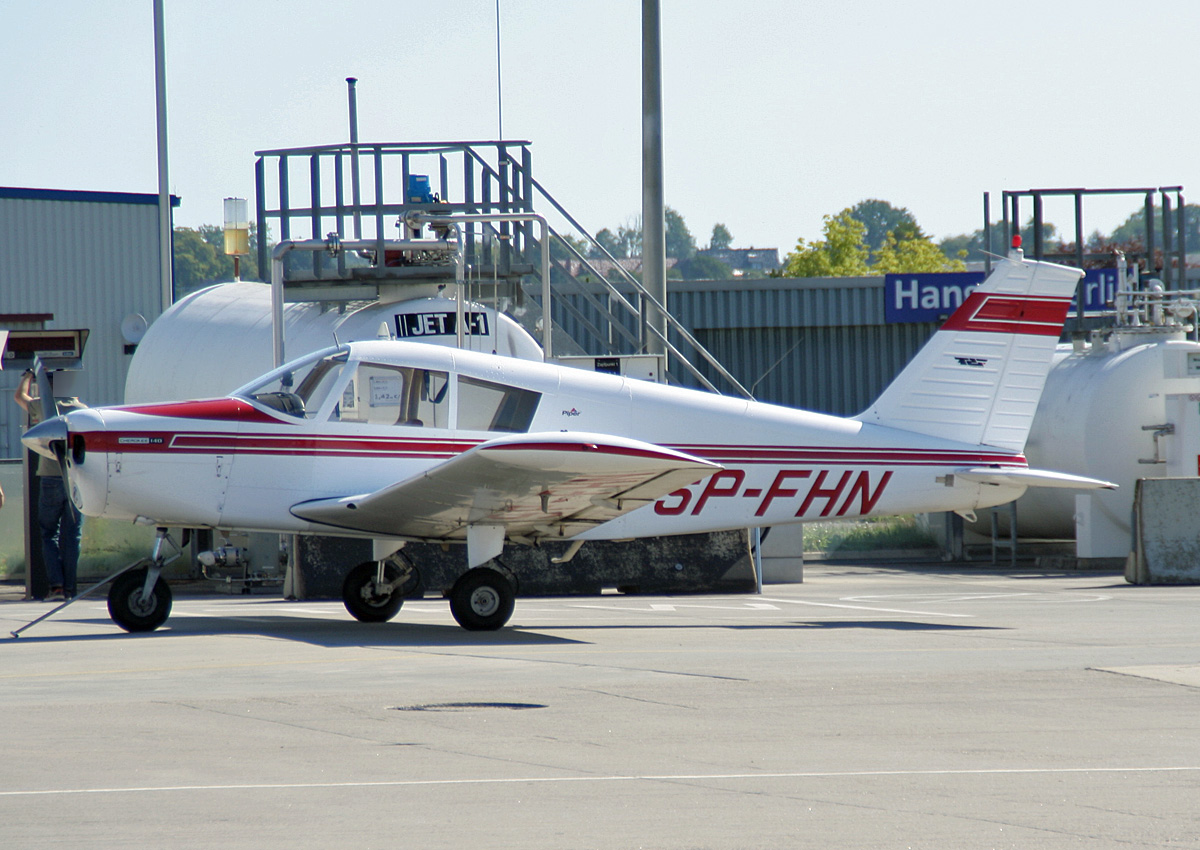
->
[1016,328,1200,540]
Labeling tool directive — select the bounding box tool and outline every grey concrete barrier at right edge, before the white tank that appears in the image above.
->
[1126,478,1200,585]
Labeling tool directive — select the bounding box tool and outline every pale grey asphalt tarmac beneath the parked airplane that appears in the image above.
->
[0,564,1200,850]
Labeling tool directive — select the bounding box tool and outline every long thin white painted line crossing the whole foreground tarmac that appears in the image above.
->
[0,766,1200,797]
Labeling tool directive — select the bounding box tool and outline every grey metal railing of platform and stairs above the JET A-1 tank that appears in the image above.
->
[256,139,751,397]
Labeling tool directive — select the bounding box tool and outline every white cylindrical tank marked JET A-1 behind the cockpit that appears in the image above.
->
[125,281,542,405]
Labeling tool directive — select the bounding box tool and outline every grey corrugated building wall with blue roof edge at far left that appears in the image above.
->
[0,187,162,457]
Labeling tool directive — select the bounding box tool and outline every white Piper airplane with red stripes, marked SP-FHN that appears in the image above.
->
[23,250,1112,631]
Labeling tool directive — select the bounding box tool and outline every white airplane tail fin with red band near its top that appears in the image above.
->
[856,249,1084,451]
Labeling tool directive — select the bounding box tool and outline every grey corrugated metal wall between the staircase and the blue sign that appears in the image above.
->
[562,277,937,415]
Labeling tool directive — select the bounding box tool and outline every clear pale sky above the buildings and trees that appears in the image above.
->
[0,0,1200,252]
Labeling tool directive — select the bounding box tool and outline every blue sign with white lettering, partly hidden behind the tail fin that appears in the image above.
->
[883,269,1117,324]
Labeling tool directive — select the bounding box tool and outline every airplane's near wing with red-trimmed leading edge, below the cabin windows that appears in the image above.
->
[292,431,722,567]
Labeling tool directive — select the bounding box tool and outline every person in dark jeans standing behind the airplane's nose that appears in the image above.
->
[16,371,85,601]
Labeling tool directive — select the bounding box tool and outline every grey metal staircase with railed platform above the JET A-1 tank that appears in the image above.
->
[254,140,750,397]
